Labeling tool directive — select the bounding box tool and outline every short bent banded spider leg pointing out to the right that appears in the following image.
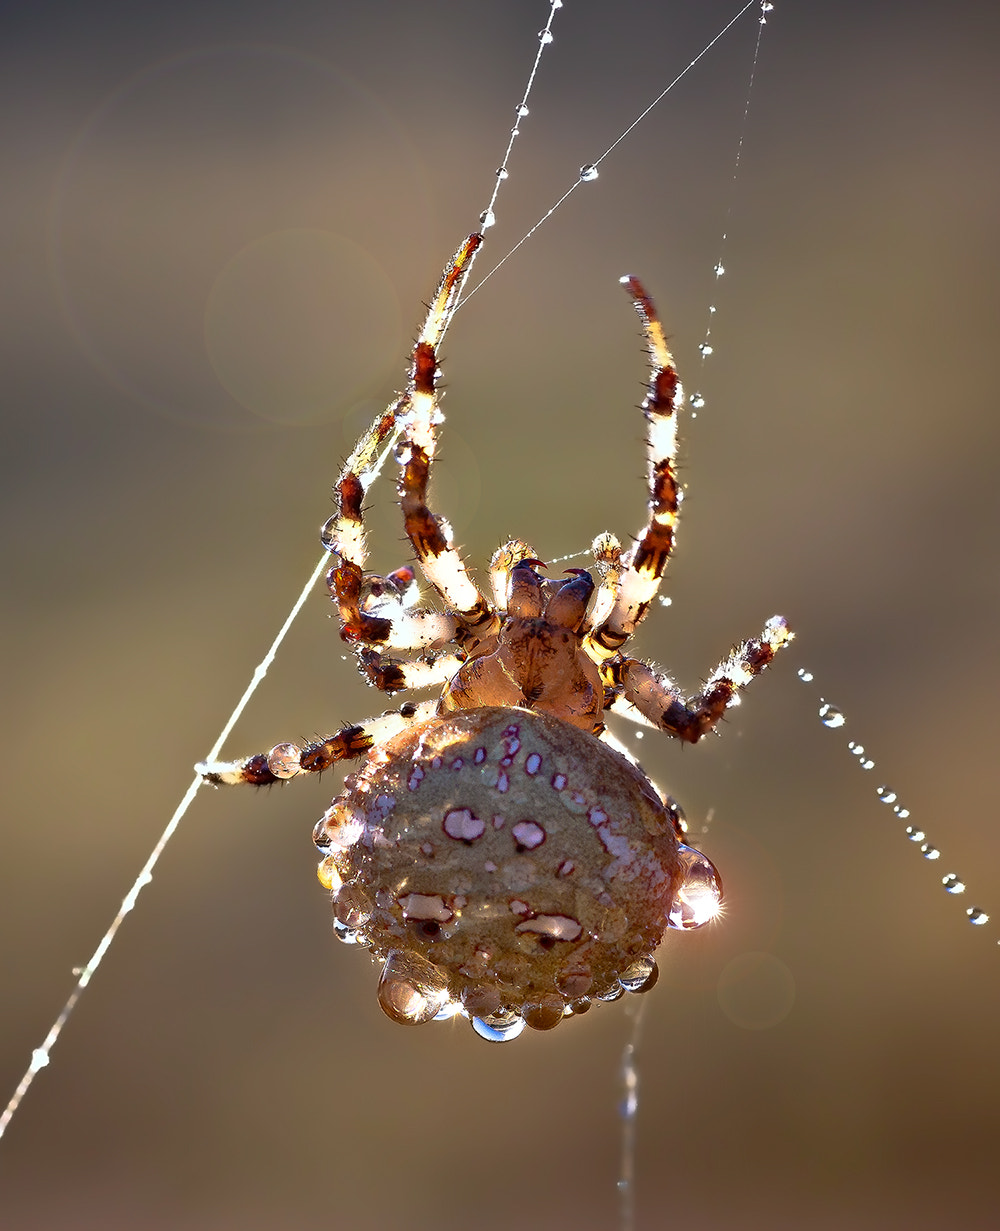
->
[602,616,794,744]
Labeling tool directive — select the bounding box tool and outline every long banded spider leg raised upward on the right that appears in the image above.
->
[587,276,683,662]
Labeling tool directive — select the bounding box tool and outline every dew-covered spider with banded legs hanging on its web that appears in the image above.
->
[198,234,792,1041]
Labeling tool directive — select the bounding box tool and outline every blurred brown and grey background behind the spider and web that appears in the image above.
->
[0,0,1000,1231]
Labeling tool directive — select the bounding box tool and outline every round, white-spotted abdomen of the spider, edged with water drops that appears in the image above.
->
[315,707,686,1027]
